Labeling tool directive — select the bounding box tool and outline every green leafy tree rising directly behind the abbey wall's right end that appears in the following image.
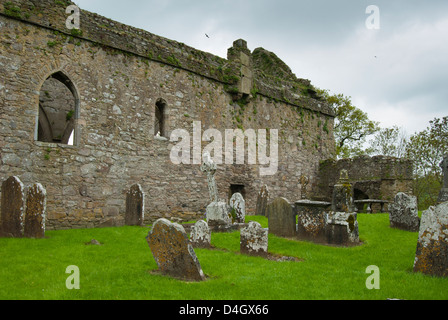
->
[318,90,379,158]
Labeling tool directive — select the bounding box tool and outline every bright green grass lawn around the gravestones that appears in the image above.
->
[0,214,448,300]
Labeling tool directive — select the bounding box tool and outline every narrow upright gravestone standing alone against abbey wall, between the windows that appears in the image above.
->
[124,184,145,226]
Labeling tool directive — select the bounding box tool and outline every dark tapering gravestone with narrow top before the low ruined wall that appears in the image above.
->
[331,170,356,212]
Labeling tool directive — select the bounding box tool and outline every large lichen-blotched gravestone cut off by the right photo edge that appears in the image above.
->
[414,202,448,277]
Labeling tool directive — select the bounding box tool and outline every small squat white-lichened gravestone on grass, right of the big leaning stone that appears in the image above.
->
[240,221,268,257]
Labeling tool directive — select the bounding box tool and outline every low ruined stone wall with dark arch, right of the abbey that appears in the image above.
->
[315,156,413,206]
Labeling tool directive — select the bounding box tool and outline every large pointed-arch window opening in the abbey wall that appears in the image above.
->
[36,72,78,145]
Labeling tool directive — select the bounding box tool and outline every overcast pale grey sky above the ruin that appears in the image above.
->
[75,0,448,134]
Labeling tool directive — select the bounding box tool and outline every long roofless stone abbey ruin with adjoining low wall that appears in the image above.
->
[0,0,412,229]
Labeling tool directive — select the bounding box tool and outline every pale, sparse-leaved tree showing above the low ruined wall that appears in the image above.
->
[370,126,408,158]
